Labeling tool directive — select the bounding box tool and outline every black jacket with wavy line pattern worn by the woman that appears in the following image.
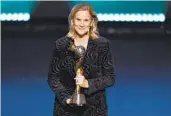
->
[48,36,115,116]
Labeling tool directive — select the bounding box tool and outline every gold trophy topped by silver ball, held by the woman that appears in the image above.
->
[71,44,86,106]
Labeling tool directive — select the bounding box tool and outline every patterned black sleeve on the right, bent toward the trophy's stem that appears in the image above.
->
[85,41,115,95]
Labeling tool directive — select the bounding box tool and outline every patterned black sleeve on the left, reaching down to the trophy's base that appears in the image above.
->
[47,41,71,105]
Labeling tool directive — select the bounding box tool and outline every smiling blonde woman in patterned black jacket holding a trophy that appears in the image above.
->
[48,4,115,116]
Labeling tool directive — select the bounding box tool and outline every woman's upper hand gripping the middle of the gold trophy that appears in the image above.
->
[74,75,89,88]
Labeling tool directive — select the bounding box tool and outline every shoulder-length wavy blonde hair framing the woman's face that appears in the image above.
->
[67,4,99,39]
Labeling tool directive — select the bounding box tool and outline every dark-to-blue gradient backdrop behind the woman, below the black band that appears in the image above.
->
[1,35,171,116]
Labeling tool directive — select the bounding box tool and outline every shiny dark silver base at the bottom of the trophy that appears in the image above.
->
[71,93,86,106]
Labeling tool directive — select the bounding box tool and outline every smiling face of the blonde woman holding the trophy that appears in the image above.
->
[73,10,91,37]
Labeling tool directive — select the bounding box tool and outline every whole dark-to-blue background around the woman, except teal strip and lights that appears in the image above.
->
[1,2,171,116]
